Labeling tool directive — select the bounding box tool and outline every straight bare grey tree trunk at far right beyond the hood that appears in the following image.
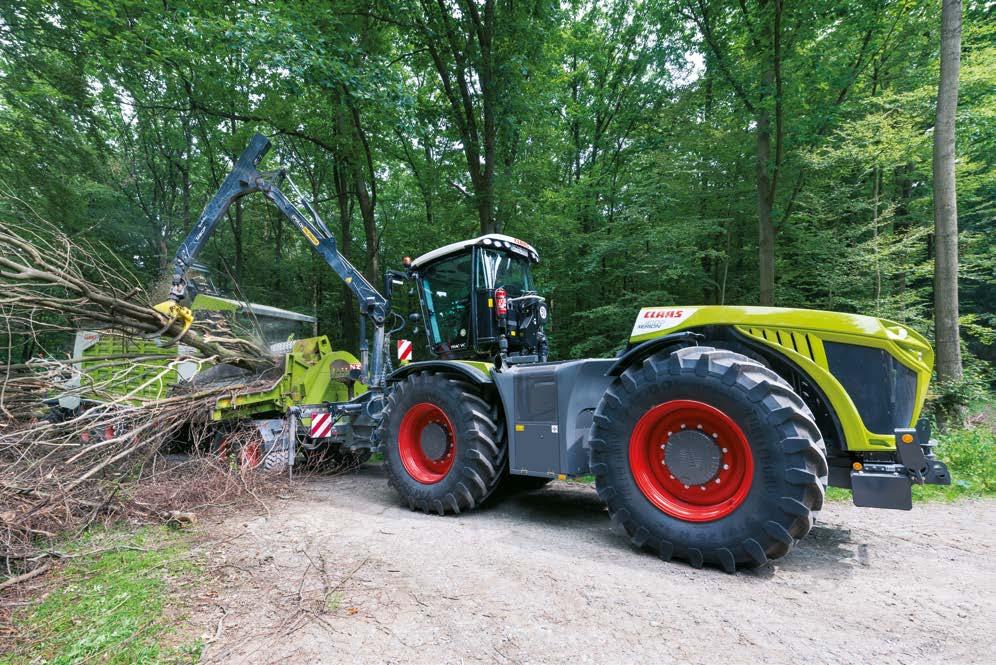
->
[933,0,962,381]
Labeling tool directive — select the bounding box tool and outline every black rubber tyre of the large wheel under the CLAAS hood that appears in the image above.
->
[590,347,827,573]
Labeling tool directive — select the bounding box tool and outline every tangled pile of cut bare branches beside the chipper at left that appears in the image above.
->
[0,200,274,589]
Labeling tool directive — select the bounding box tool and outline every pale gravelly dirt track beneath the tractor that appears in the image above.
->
[194,466,996,665]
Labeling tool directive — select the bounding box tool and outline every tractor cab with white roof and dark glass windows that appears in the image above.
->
[409,233,549,364]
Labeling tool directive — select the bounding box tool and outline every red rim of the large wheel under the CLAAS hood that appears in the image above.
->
[629,400,754,522]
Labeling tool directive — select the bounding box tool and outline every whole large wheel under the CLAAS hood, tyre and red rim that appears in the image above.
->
[590,347,827,572]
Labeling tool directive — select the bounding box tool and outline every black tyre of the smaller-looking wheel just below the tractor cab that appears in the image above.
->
[380,372,508,515]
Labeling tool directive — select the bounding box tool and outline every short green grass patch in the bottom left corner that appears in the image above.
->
[0,527,202,665]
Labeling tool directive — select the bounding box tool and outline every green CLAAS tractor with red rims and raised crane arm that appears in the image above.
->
[158,135,950,572]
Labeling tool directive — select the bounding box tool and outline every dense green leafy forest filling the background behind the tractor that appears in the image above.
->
[0,0,996,374]
